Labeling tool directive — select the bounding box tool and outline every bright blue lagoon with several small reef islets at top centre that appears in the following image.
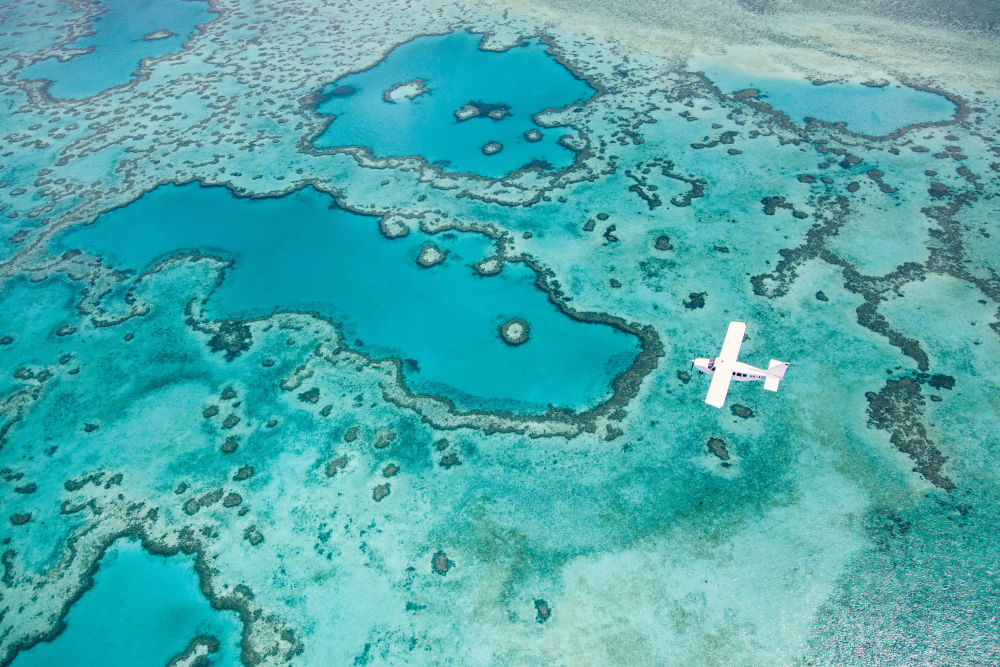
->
[313,32,595,178]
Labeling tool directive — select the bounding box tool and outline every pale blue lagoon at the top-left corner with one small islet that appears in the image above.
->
[18,0,215,99]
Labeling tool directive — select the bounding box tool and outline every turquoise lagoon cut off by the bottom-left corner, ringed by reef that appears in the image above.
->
[12,540,241,667]
